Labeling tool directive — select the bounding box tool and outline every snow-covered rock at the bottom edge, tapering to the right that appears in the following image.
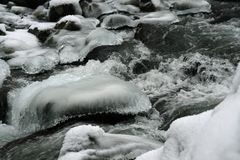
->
[58,125,161,160]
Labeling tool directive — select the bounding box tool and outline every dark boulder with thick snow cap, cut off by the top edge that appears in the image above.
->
[48,0,82,21]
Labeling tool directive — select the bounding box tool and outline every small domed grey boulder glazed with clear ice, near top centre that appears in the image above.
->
[101,14,137,29]
